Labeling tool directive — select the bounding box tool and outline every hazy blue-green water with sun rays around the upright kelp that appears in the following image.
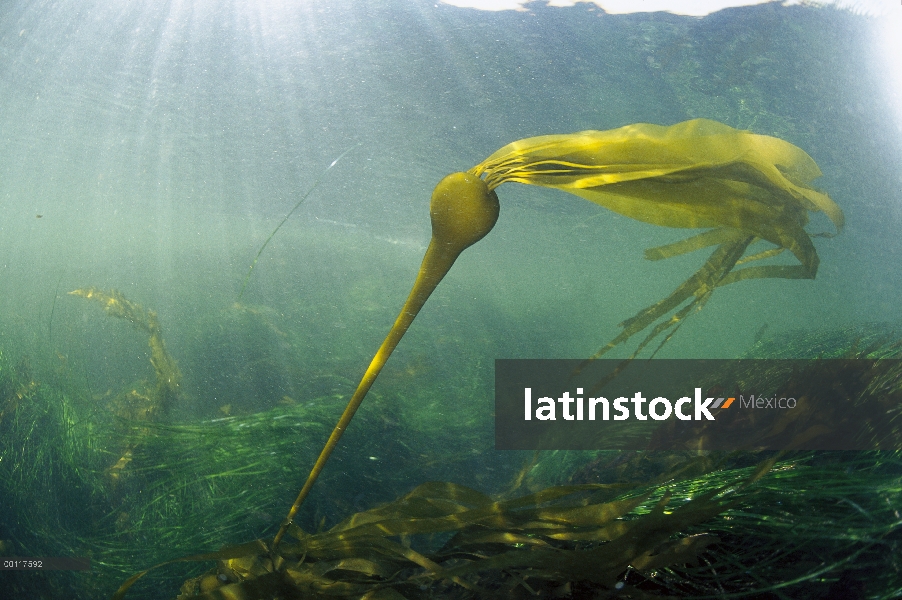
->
[0,0,902,597]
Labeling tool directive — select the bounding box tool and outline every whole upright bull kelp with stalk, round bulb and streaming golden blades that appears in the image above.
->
[273,119,843,548]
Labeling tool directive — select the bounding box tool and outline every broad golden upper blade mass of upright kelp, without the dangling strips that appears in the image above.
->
[470,119,843,267]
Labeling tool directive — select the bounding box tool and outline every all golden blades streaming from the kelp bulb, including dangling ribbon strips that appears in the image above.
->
[469,119,843,357]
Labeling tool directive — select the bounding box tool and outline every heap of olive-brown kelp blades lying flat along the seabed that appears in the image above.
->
[114,460,773,600]
